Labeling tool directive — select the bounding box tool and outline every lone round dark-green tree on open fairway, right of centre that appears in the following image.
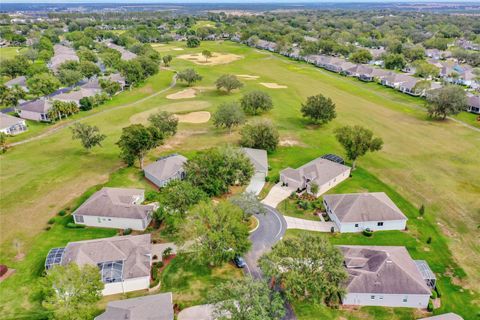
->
[301,94,337,124]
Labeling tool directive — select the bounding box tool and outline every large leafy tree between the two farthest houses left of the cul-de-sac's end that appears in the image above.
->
[184,147,253,196]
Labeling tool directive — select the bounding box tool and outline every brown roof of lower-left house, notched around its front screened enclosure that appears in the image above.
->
[61,234,152,283]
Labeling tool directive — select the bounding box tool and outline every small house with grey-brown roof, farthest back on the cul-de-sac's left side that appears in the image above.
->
[143,153,188,188]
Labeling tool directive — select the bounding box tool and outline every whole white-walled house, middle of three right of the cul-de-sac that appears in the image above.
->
[323,192,407,232]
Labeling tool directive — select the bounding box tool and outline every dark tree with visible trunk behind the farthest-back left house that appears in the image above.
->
[117,124,163,169]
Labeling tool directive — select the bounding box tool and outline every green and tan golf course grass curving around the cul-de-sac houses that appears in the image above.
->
[0,42,480,319]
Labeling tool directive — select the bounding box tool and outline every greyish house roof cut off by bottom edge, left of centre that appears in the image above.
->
[94,292,174,320]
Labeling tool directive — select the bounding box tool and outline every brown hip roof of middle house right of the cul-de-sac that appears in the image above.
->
[323,192,407,222]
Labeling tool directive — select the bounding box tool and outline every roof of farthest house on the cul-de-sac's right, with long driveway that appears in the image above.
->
[280,157,350,185]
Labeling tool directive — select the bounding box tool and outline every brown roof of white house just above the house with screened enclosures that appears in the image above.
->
[73,188,156,219]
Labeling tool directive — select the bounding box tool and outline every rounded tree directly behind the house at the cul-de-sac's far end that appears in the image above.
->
[240,120,279,152]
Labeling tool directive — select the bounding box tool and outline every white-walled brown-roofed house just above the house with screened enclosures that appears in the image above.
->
[73,188,158,230]
